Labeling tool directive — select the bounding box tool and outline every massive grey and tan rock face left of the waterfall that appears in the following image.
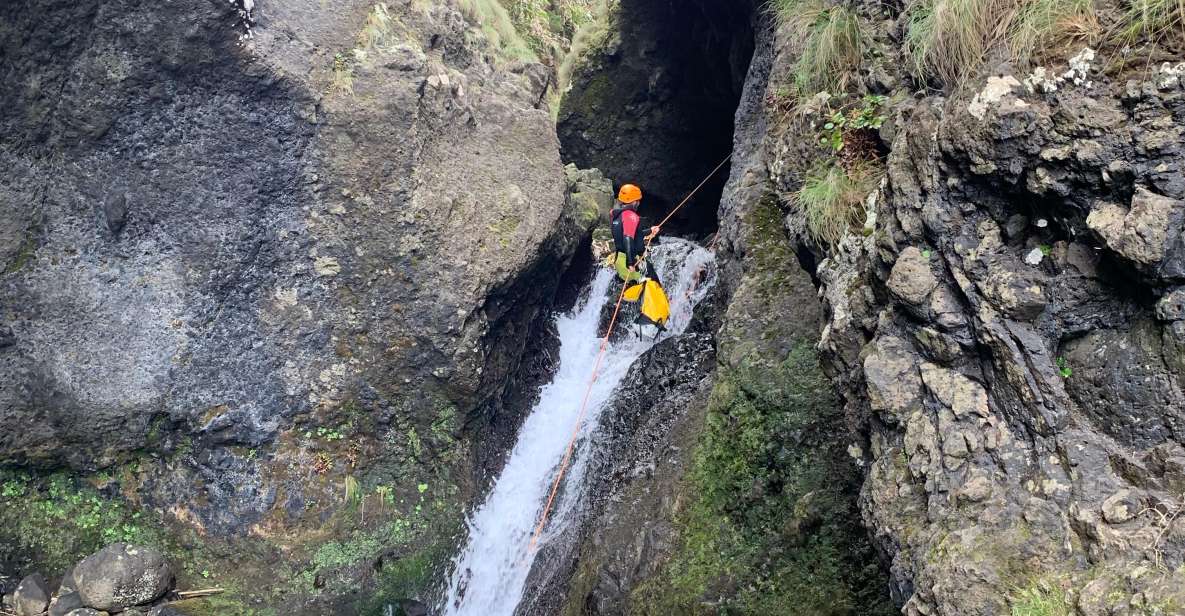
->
[0,0,583,533]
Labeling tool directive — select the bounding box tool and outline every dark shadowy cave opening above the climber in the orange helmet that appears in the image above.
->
[558,0,754,238]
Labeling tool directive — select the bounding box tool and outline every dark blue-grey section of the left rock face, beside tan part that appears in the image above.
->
[0,2,313,466]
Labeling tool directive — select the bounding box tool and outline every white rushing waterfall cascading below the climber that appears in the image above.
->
[441,238,716,616]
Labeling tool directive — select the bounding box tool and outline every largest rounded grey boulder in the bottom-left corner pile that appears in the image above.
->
[73,544,173,611]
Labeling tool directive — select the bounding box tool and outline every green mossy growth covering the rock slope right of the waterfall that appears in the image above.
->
[630,344,893,615]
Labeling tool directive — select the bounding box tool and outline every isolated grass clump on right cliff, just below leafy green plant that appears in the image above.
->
[794,160,880,246]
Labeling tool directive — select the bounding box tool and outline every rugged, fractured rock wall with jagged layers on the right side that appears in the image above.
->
[805,57,1185,615]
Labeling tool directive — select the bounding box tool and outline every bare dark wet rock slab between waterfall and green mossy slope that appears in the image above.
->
[518,332,716,616]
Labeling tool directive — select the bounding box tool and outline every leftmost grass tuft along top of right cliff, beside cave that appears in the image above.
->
[789,4,865,98]
